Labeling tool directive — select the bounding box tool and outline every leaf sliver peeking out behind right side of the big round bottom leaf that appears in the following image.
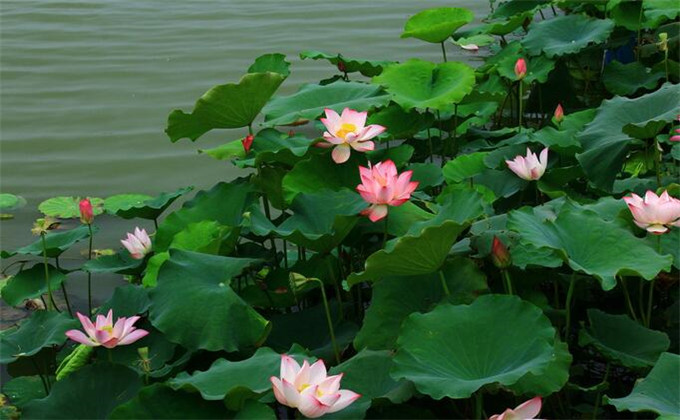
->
[509,339,573,396]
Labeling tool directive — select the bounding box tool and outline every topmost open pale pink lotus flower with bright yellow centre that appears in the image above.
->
[319,108,385,163]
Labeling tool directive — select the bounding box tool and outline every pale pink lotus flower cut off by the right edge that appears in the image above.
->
[623,191,680,235]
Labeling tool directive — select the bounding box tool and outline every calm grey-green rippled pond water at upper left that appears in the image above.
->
[0,0,488,306]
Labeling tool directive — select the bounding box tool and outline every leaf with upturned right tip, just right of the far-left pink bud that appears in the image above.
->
[104,187,194,220]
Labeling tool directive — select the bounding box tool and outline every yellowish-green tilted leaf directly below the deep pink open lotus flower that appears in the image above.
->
[347,221,465,287]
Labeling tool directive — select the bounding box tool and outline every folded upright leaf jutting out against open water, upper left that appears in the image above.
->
[170,72,285,142]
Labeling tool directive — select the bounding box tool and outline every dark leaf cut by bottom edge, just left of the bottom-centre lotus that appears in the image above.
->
[110,383,225,420]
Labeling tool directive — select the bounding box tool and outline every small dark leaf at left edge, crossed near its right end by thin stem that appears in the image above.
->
[2,263,66,306]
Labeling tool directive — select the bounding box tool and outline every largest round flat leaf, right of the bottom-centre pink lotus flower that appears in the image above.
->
[392,295,555,400]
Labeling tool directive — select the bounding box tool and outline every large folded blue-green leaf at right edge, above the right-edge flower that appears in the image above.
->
[576,83,680,191]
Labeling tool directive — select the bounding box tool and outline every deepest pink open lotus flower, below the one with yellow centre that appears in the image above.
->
[357,160,418,222]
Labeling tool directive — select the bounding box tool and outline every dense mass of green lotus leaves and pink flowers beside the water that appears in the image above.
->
[0,0,680,419]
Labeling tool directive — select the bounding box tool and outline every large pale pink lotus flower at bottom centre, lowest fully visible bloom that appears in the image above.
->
[269,354,361,418]
